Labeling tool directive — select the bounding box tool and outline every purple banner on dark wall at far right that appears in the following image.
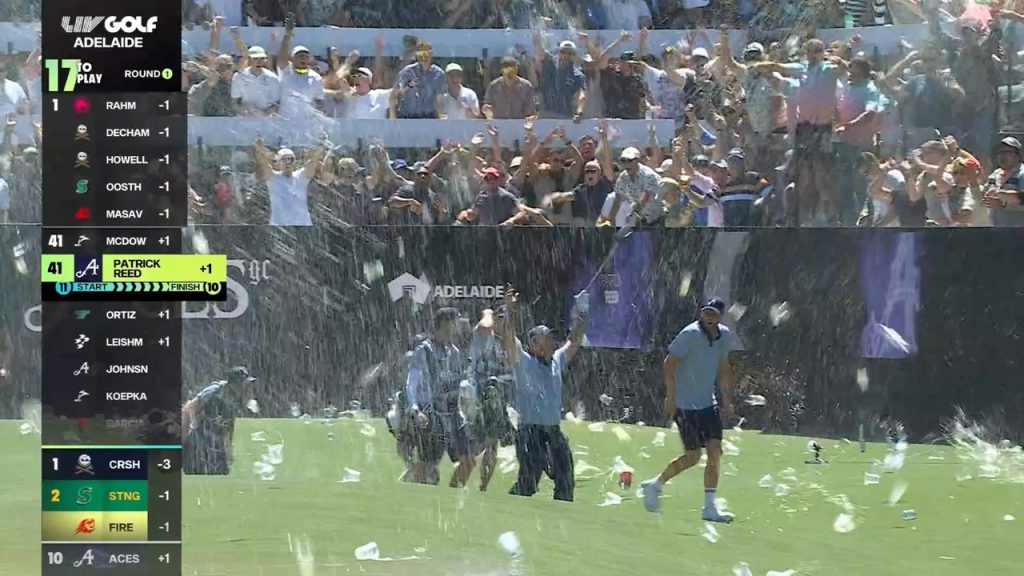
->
[860,233,921,359]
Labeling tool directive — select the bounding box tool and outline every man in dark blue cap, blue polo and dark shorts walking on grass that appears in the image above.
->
[641,298,735,523]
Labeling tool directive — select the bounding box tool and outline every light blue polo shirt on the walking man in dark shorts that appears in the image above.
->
[669,322,735,410]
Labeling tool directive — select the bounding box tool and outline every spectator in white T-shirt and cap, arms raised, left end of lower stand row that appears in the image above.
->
[256,138,324,227]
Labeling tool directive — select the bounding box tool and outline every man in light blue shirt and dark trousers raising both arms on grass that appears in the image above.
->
[502,286,590,502]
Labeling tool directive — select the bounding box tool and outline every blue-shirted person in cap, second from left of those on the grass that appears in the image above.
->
[403,307,475,488]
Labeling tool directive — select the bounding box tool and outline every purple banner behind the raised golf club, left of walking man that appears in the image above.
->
[565,231,654,348]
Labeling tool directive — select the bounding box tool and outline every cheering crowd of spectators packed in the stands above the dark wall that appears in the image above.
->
[0,0,1024,227]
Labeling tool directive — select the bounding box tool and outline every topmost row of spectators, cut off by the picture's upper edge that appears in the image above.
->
[183,0,892,31]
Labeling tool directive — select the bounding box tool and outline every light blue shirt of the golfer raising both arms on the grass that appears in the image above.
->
[513,340,568,426]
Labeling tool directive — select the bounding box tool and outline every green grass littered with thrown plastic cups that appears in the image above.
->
[0,419,1024,576]
